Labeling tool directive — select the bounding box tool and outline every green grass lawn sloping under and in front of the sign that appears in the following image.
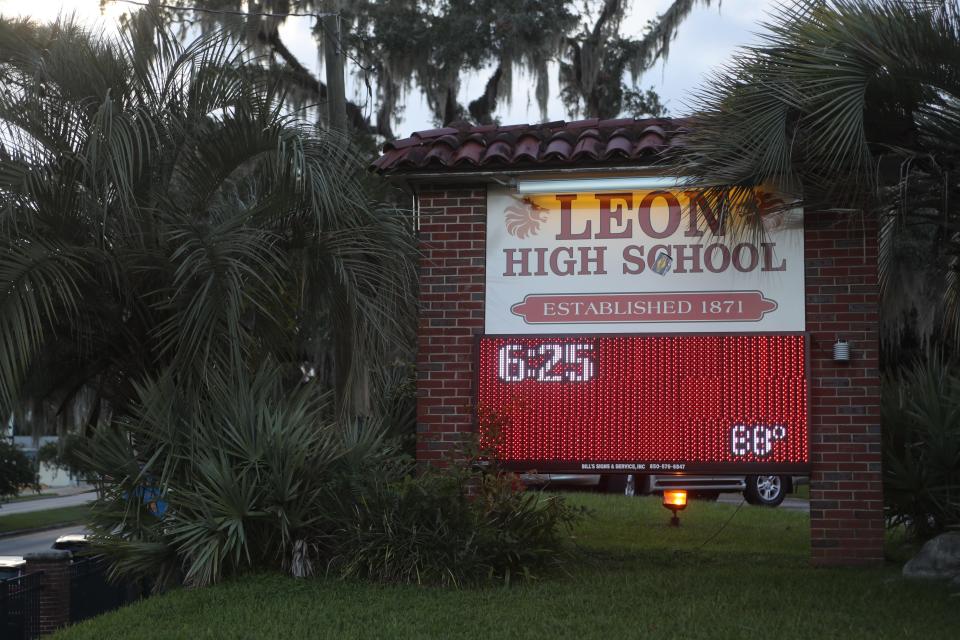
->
[55,494,960,640]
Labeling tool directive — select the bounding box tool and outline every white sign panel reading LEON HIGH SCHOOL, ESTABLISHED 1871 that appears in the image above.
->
[486,186,805,334]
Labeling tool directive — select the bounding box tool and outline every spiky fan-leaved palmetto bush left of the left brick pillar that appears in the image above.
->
[80,363,405,588]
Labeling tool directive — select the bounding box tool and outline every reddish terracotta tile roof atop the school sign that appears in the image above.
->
[370,118,686,174]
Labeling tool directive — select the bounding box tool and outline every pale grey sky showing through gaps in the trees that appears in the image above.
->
[0,0,777,137]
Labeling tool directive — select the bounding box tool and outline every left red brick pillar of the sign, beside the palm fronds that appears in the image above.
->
[417,186,487,465]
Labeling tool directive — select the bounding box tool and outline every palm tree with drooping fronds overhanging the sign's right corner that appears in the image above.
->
[672,0,960,358]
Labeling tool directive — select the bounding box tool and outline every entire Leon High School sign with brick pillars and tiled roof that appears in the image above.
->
[371,119,883,564]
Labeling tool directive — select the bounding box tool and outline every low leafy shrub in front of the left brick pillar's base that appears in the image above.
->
[331,468,581,586]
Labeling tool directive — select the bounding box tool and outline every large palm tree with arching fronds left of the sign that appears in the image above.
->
[0,12,413,436]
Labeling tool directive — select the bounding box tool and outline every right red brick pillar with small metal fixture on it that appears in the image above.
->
[805,213,883,565]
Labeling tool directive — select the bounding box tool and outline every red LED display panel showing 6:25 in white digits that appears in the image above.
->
[477,335,809,473]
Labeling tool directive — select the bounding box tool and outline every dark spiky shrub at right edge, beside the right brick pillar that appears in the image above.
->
[883,355,960,538]
